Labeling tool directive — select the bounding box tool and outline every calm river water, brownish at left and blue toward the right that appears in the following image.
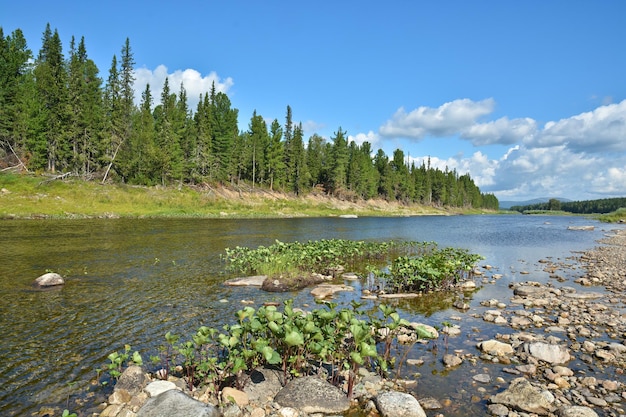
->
[0,216,613,416]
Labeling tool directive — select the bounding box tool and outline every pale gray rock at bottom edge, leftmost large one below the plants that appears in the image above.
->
[137,389,221,417]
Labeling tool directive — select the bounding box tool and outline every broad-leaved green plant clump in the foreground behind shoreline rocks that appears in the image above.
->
[103,300,432,397]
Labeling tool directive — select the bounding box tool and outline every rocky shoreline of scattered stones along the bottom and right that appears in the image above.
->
[94,230,626,417]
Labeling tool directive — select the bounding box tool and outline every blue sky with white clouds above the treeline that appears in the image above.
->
[0,0,626,200]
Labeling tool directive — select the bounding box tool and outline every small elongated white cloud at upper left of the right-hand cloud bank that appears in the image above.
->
[379,98,495,140]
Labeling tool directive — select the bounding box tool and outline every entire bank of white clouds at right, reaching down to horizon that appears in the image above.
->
[370,99,626,200]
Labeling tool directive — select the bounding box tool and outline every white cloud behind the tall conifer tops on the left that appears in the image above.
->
[134,65,234,110]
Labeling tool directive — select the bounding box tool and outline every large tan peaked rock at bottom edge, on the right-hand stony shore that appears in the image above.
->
[490,378,555,415]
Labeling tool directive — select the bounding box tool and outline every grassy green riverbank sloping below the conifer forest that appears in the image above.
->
[0,173,488,219]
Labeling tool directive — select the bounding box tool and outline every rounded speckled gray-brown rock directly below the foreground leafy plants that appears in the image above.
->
[274,376,350,414]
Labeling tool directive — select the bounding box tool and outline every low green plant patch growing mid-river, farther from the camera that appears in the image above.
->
[222,239,484,292]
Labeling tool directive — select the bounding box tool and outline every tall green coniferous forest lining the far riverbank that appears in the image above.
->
[0,24,498,209]
